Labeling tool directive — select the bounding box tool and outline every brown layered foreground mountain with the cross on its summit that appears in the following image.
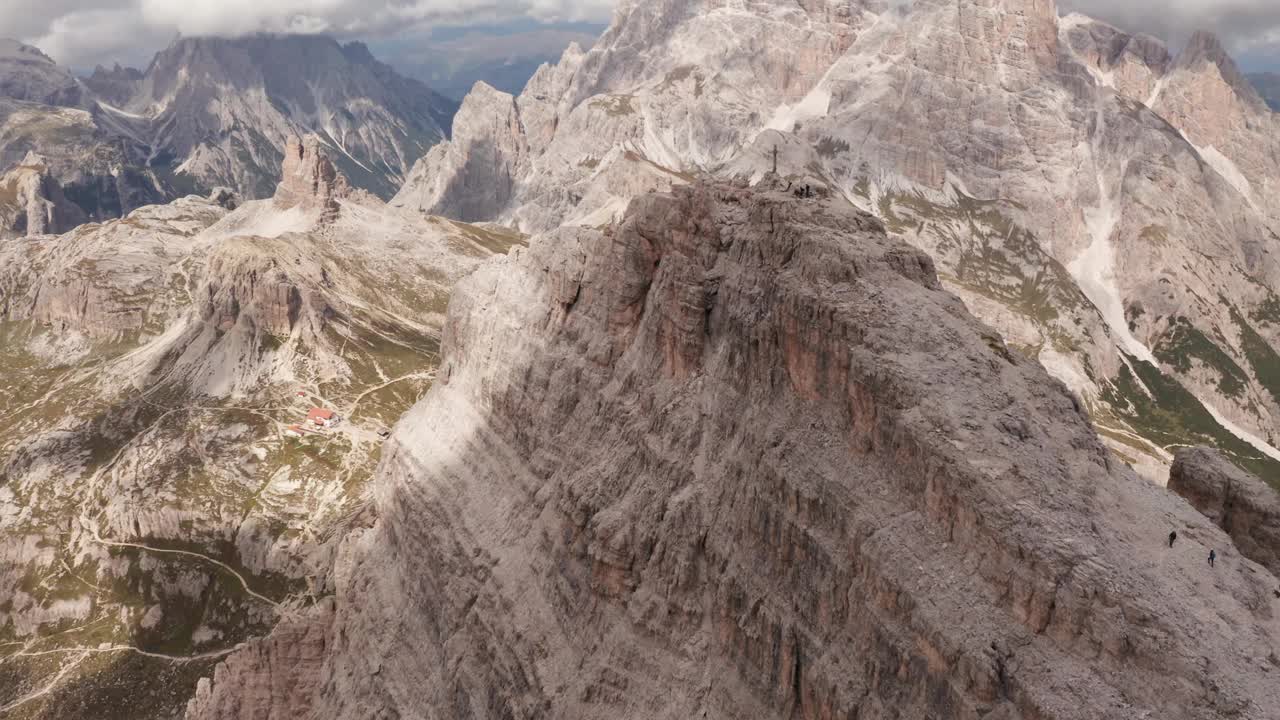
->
[188,181,1280,720]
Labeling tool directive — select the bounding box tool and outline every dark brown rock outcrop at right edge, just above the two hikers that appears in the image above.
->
[1169,447,1280,578]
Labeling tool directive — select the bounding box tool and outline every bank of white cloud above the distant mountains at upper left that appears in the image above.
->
[0,0,613,68]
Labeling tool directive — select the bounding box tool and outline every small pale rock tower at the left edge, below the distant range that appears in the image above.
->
[0,152,87,237]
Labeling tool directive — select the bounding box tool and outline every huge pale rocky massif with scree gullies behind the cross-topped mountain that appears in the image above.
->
[394,0,1280,482]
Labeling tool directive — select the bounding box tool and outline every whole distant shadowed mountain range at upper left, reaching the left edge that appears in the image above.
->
[0,35,456,233]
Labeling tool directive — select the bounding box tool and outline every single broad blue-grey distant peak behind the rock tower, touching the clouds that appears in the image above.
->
[119,35,456,199]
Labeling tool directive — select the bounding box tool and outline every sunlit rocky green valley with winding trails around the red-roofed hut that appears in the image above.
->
[0,137,522,717]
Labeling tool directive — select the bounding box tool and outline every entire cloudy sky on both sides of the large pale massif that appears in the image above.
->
[0,0,1280,69]
